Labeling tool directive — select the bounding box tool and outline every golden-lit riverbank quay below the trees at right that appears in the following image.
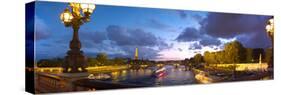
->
[192,68,273,84]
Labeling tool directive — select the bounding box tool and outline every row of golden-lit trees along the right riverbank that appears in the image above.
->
[186,41,273,65]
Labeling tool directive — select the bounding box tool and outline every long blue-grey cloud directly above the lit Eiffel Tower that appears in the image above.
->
[106,25,167,47]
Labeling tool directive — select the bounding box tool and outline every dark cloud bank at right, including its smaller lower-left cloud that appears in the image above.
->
[176,13,271,48]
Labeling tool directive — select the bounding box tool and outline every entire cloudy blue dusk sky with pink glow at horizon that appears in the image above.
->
[30,2,271,60]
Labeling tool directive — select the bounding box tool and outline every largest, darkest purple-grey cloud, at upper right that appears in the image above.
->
[201,13,267,38]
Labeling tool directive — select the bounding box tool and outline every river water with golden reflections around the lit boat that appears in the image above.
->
[91,65,195,86]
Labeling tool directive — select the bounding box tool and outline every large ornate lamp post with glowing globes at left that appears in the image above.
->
[60,3,95,73]
